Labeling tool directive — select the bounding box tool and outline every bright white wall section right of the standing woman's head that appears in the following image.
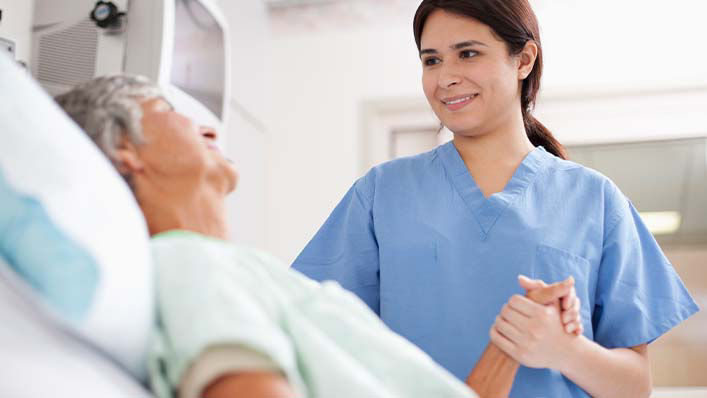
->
[536,0,707,89]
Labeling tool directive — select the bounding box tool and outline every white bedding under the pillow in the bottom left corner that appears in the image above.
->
[0,259,151,398]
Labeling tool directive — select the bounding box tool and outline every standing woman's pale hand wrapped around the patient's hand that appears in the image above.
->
[491,278,577,369]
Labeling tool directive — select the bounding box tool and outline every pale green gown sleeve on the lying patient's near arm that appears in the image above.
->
[150,238,304,396]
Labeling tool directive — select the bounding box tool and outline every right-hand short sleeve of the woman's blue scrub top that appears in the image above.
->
[592,194,699,348]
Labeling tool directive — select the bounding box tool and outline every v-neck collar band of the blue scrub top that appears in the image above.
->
[437,141,552,239]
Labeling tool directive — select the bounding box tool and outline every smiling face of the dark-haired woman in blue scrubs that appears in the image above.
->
[420,10,525,136]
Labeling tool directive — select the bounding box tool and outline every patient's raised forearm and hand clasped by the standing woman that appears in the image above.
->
[466,279,574,398]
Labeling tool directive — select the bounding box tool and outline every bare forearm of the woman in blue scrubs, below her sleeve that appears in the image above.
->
[558,336,652,398]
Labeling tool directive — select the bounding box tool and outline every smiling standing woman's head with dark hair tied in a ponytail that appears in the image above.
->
[414,1,567,159]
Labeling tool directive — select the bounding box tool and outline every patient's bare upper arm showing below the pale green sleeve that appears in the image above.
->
[201,372,295,398]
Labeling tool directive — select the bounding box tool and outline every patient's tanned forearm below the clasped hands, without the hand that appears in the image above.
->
[466,343,520,398]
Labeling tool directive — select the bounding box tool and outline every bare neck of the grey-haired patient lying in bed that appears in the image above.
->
[137,180,228,239]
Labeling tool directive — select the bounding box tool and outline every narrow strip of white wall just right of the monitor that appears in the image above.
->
[216,0,271,248]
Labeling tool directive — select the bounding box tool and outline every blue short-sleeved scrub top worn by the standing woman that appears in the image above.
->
[293,142,698,398]
